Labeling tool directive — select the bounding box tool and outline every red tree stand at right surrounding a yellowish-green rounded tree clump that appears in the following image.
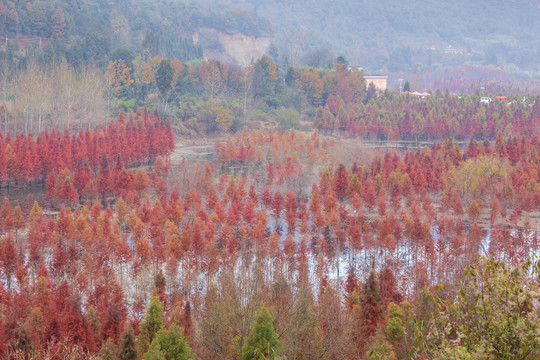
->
[314,135,540,211]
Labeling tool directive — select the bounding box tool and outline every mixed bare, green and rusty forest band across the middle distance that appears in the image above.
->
[0,52,540,140]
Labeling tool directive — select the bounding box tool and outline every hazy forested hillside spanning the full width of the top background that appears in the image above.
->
[0,0,540,77]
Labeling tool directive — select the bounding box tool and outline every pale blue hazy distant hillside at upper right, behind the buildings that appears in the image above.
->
[243,0,540,72]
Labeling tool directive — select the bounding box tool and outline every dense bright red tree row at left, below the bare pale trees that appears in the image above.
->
[0,110,174,183]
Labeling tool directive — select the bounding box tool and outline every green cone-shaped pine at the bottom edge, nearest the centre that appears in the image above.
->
[242,305,281,360]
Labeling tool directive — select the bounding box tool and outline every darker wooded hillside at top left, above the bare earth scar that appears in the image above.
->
[0,0,270,64]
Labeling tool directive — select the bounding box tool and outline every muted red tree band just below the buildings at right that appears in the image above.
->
[314,95,540,140]
